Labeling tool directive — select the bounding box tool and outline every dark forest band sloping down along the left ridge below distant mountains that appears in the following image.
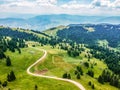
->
[0,27,62,47]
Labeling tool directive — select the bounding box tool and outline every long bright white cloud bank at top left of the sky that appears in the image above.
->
[1,0,57,7]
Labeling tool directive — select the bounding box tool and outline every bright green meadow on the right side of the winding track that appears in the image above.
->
[37,46,118,90]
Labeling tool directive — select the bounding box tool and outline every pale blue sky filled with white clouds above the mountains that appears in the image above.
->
[0,0,120,16]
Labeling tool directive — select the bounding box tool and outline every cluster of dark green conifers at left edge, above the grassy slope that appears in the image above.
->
[0,36,26,59]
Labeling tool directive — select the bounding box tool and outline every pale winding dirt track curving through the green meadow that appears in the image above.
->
[27,49,85,90]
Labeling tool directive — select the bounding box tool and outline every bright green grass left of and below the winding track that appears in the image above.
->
[0,48,79,90]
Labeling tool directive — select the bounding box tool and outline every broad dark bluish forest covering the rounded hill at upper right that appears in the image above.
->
[57,24,120,47]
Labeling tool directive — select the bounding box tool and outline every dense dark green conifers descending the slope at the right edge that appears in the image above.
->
[89,46,120,74]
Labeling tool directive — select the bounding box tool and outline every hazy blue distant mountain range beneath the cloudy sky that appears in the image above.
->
[0,14,120,31]
